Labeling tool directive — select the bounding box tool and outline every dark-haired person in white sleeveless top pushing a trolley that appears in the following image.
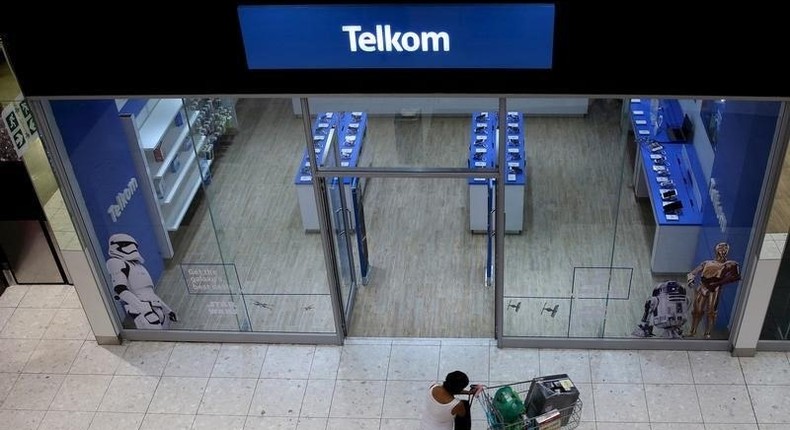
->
[420,370,483,430]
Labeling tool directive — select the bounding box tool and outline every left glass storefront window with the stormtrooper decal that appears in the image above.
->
[51,98,335,334]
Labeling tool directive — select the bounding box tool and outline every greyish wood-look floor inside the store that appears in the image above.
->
[150,99,744,338]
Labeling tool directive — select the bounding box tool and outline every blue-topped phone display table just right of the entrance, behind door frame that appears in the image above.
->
[468,112,527,233]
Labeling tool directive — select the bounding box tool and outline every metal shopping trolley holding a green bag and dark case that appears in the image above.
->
[477,375,582,430]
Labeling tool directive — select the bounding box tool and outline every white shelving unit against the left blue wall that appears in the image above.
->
[119,99,213,258]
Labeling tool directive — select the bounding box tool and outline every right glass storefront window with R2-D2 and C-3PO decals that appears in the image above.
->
[503,98,780,339]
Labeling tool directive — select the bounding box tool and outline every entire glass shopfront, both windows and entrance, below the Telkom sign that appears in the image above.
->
[35,92,780,339]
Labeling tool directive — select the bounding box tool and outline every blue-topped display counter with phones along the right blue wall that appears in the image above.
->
[628,99,704,273]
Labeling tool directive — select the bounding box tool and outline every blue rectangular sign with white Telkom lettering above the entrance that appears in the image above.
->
[238,4,554,70]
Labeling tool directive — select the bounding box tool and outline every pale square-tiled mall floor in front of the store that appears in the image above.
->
[0,286,790,430]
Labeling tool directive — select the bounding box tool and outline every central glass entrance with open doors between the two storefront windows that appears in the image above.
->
[308,97,497,338]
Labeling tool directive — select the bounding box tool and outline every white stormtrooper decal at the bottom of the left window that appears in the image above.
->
[107,233,178,330]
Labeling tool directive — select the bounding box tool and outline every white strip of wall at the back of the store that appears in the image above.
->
[292,96,588,116]
